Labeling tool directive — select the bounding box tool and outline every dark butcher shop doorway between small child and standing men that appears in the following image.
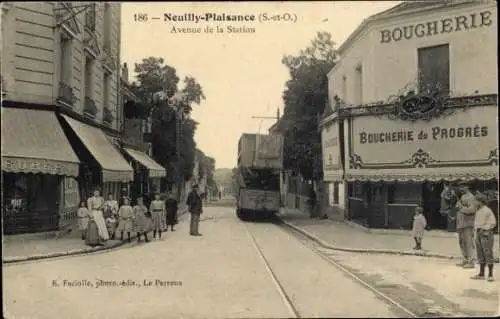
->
[422,182,448,229]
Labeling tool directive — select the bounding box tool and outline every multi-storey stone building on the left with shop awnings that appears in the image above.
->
[2,2,133,234]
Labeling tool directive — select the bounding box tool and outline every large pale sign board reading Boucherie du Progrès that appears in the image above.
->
[350,106,498,168]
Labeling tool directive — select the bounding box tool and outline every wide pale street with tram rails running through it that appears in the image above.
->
[3,207,498,318]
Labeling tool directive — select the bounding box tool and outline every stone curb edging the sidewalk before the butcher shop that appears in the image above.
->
[281,220,461,260]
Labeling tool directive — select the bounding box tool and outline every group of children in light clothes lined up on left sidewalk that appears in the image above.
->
[74,194,177,242]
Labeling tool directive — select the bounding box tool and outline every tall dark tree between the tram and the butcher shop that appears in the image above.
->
[281,32,337,180]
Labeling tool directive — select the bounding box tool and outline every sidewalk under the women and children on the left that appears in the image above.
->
[2,207,187,264]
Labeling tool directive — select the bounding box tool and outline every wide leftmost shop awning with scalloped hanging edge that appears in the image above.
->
[2,107,80,177]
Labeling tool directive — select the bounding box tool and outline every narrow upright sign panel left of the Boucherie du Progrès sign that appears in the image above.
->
[321,123,342,174]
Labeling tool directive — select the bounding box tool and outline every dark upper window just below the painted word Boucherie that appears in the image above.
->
[418,44,450,95]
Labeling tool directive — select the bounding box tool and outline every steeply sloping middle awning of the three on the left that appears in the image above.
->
[63,115,134,182]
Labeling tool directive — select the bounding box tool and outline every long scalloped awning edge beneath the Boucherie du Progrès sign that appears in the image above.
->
[345,165,498,182]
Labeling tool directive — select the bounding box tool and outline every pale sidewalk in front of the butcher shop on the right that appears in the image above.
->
[280,209,500,259]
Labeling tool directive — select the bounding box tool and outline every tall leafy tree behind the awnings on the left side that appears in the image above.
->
[131,57,205,188]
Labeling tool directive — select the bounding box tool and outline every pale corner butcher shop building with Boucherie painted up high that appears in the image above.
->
[323,1,498,230]
